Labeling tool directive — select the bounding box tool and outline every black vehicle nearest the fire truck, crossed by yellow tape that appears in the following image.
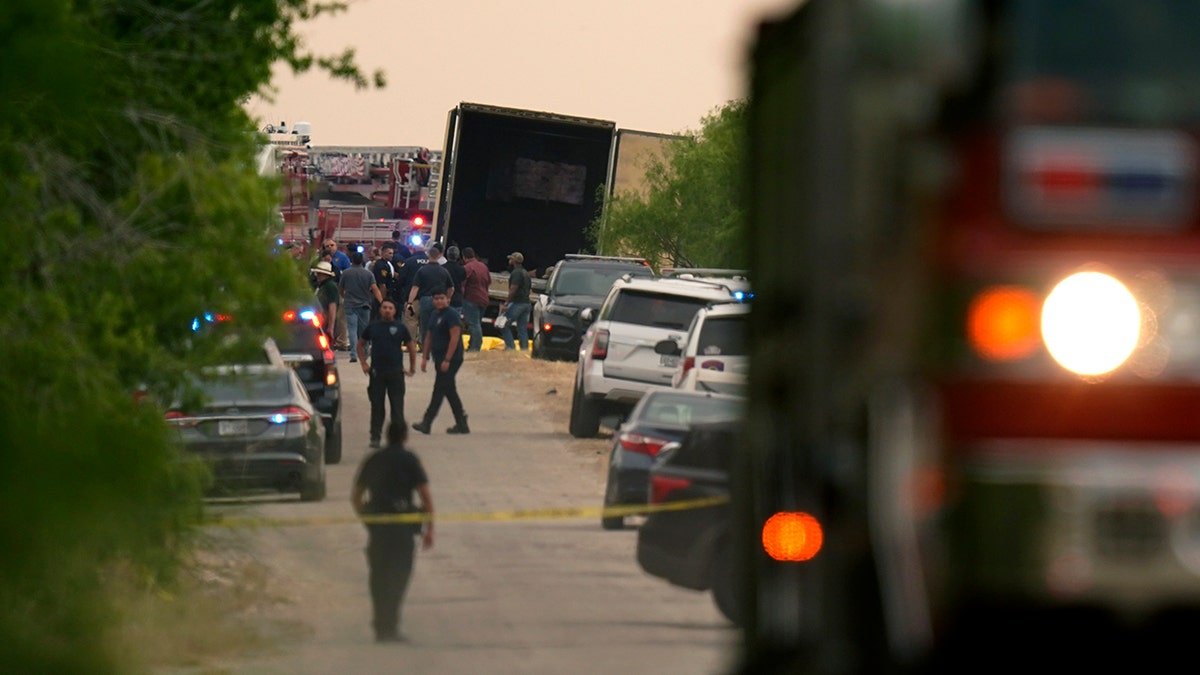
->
[637,422,744,623]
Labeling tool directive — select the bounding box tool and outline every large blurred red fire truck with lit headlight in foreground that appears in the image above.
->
[733,0,1200,673]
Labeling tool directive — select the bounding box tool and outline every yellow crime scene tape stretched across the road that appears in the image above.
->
[204,497,730,527]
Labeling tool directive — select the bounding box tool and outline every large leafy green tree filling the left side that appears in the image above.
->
[0,0,383,673]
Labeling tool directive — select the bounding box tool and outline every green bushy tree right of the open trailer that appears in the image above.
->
[589,101,748,268]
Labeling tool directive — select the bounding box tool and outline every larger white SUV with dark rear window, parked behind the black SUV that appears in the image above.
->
[570,276,748,438]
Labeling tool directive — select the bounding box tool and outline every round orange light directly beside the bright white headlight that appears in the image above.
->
[967,286,1042,362]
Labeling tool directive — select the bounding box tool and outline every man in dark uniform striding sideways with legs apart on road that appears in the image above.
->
[413,288,470,434]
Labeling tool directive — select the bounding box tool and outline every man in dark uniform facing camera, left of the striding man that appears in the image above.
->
[358,298,416,448]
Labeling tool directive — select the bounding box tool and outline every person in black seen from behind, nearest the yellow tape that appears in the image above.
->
[350,419,433,643]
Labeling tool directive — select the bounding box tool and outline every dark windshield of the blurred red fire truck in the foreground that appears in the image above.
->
[1007,0,1200,125]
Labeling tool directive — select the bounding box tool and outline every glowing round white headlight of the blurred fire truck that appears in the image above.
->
[1042,271,1141,375]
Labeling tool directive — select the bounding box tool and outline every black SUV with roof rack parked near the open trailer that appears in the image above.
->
[530,255,654,360]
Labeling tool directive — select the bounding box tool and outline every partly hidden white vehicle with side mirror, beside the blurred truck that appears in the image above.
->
[654,303,750,395]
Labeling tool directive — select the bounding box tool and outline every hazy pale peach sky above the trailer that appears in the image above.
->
[247,0,797,149]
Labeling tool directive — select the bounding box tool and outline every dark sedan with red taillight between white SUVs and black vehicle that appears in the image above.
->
[600,389,745,530]
